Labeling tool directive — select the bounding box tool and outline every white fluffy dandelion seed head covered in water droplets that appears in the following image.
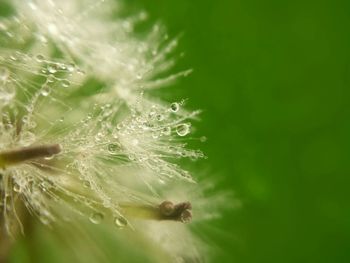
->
[0,0,224,262]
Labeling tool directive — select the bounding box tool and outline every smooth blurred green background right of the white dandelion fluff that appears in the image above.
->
[138,0,350,263]
